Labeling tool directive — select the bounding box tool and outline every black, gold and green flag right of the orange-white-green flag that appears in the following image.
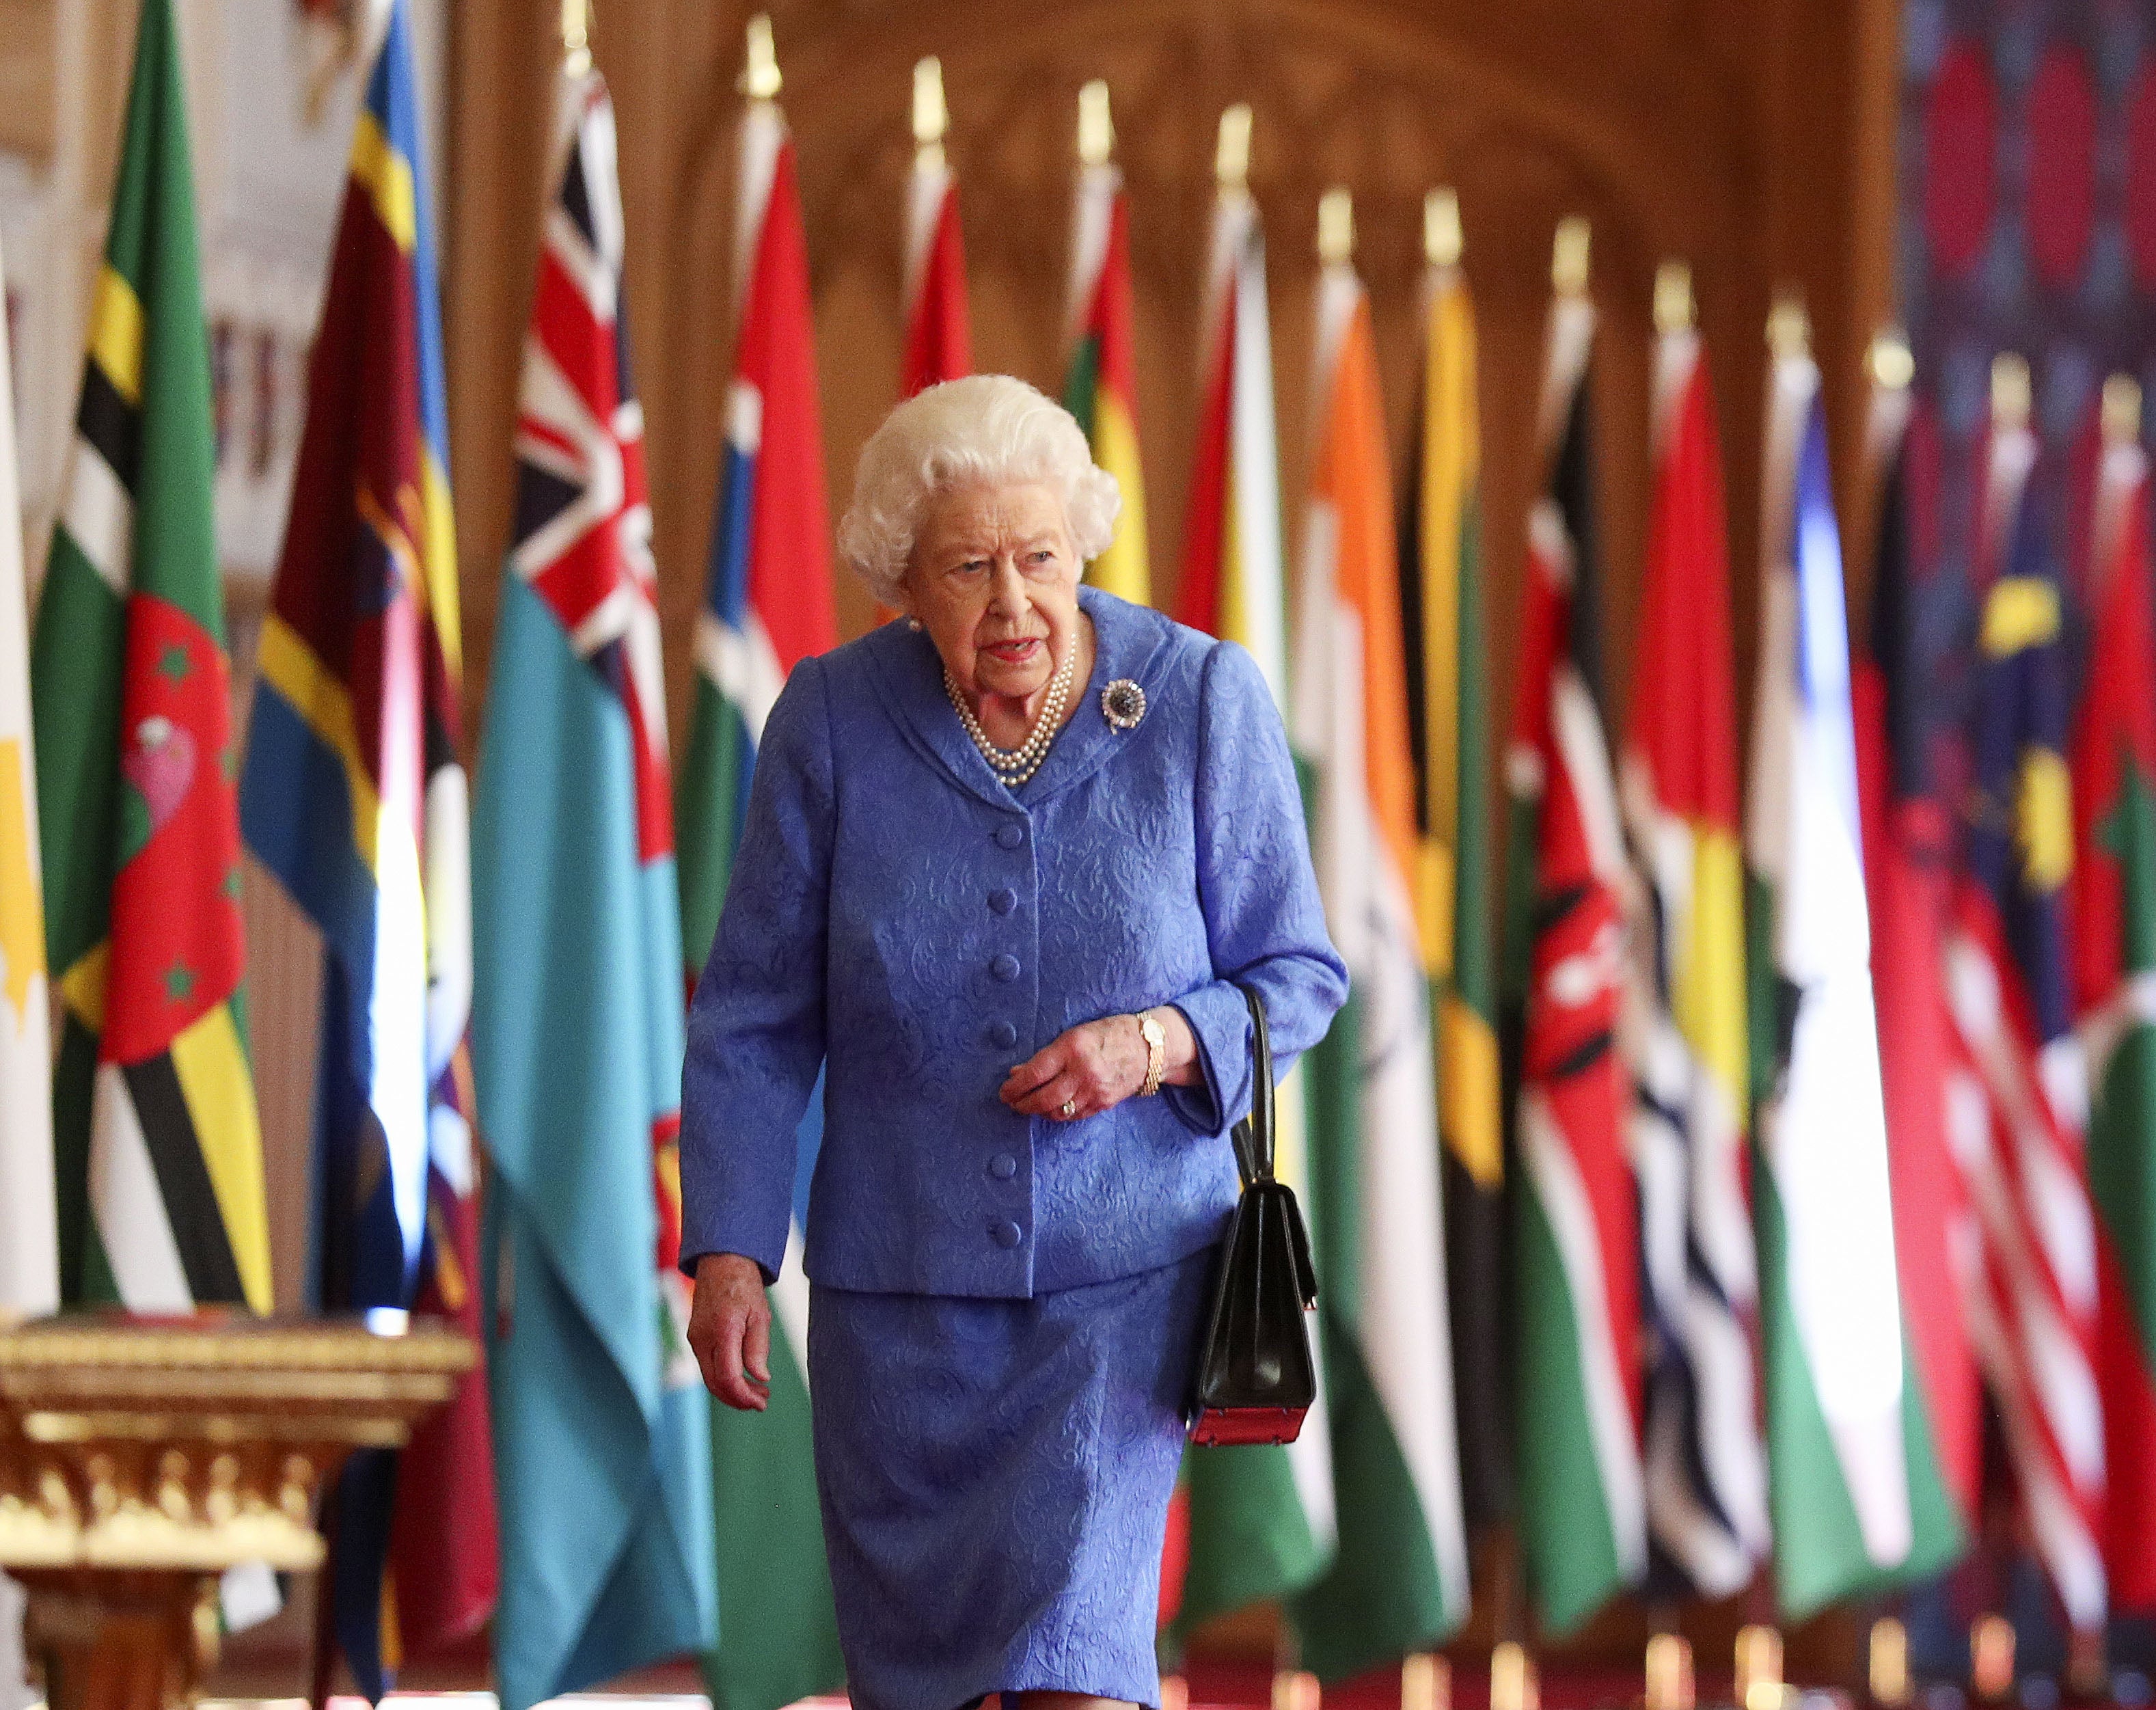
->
[1400,219,1512,1525]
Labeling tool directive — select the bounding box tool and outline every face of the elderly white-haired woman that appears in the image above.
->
[901,483,1082,698]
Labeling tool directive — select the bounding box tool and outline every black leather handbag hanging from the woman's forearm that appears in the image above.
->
[1190,986,1318,1445]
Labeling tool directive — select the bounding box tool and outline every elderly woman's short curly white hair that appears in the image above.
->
[838,373,1123,606]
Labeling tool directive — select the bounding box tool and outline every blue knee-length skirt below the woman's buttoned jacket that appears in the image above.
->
[808,1249,1214,1710]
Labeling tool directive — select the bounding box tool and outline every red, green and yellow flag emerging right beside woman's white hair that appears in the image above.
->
[1063,126,1154,606]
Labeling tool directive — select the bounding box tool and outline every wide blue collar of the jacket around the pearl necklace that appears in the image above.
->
[869,586,1169,811]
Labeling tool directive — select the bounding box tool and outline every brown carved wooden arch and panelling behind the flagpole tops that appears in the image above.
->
[448,0,1897,776]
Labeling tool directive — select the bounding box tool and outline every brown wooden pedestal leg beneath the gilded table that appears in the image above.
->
[17,1568,220,1710]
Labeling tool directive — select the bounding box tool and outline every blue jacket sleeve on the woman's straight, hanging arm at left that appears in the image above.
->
[681,660,836,1283]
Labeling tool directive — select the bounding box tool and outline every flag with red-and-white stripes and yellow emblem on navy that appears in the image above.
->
[1947,450,2112,1630]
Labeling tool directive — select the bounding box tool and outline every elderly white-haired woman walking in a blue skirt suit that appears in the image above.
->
[681,375,1346,1710]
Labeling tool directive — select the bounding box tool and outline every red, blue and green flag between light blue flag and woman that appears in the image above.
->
[677,79,845,1710]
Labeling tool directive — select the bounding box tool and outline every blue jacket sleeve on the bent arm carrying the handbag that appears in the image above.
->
[1164,642,1348,1135]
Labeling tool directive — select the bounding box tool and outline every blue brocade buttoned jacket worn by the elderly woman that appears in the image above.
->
[681,588,1348,1298]
